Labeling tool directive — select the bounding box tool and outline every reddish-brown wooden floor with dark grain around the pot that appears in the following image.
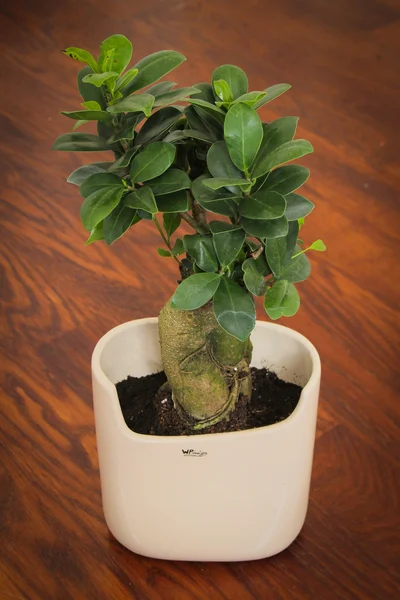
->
[0,0,400,600]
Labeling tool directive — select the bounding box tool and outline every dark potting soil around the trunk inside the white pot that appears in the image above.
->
[116,367,301,436]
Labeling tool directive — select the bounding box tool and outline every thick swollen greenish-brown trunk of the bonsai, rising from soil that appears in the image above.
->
[159,301,252,429]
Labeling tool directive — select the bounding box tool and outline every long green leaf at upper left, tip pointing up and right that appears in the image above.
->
[124,50,186,96]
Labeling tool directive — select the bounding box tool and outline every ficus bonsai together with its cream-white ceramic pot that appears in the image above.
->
[54,35,325,560]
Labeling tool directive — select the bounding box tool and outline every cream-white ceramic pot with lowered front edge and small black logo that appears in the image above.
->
[92,318,321,561]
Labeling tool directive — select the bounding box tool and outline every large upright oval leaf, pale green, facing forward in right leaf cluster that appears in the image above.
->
[224,103,263,172]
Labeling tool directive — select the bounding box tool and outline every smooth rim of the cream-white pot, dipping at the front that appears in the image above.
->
[92,317,321,444]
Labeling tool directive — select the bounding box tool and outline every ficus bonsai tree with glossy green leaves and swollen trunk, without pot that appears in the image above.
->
[53,35,325,429]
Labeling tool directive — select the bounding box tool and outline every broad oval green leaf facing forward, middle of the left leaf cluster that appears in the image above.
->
[131,142,175,182]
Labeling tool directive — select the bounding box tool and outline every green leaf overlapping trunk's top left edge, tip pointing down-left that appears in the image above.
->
[171,273,221,310]
